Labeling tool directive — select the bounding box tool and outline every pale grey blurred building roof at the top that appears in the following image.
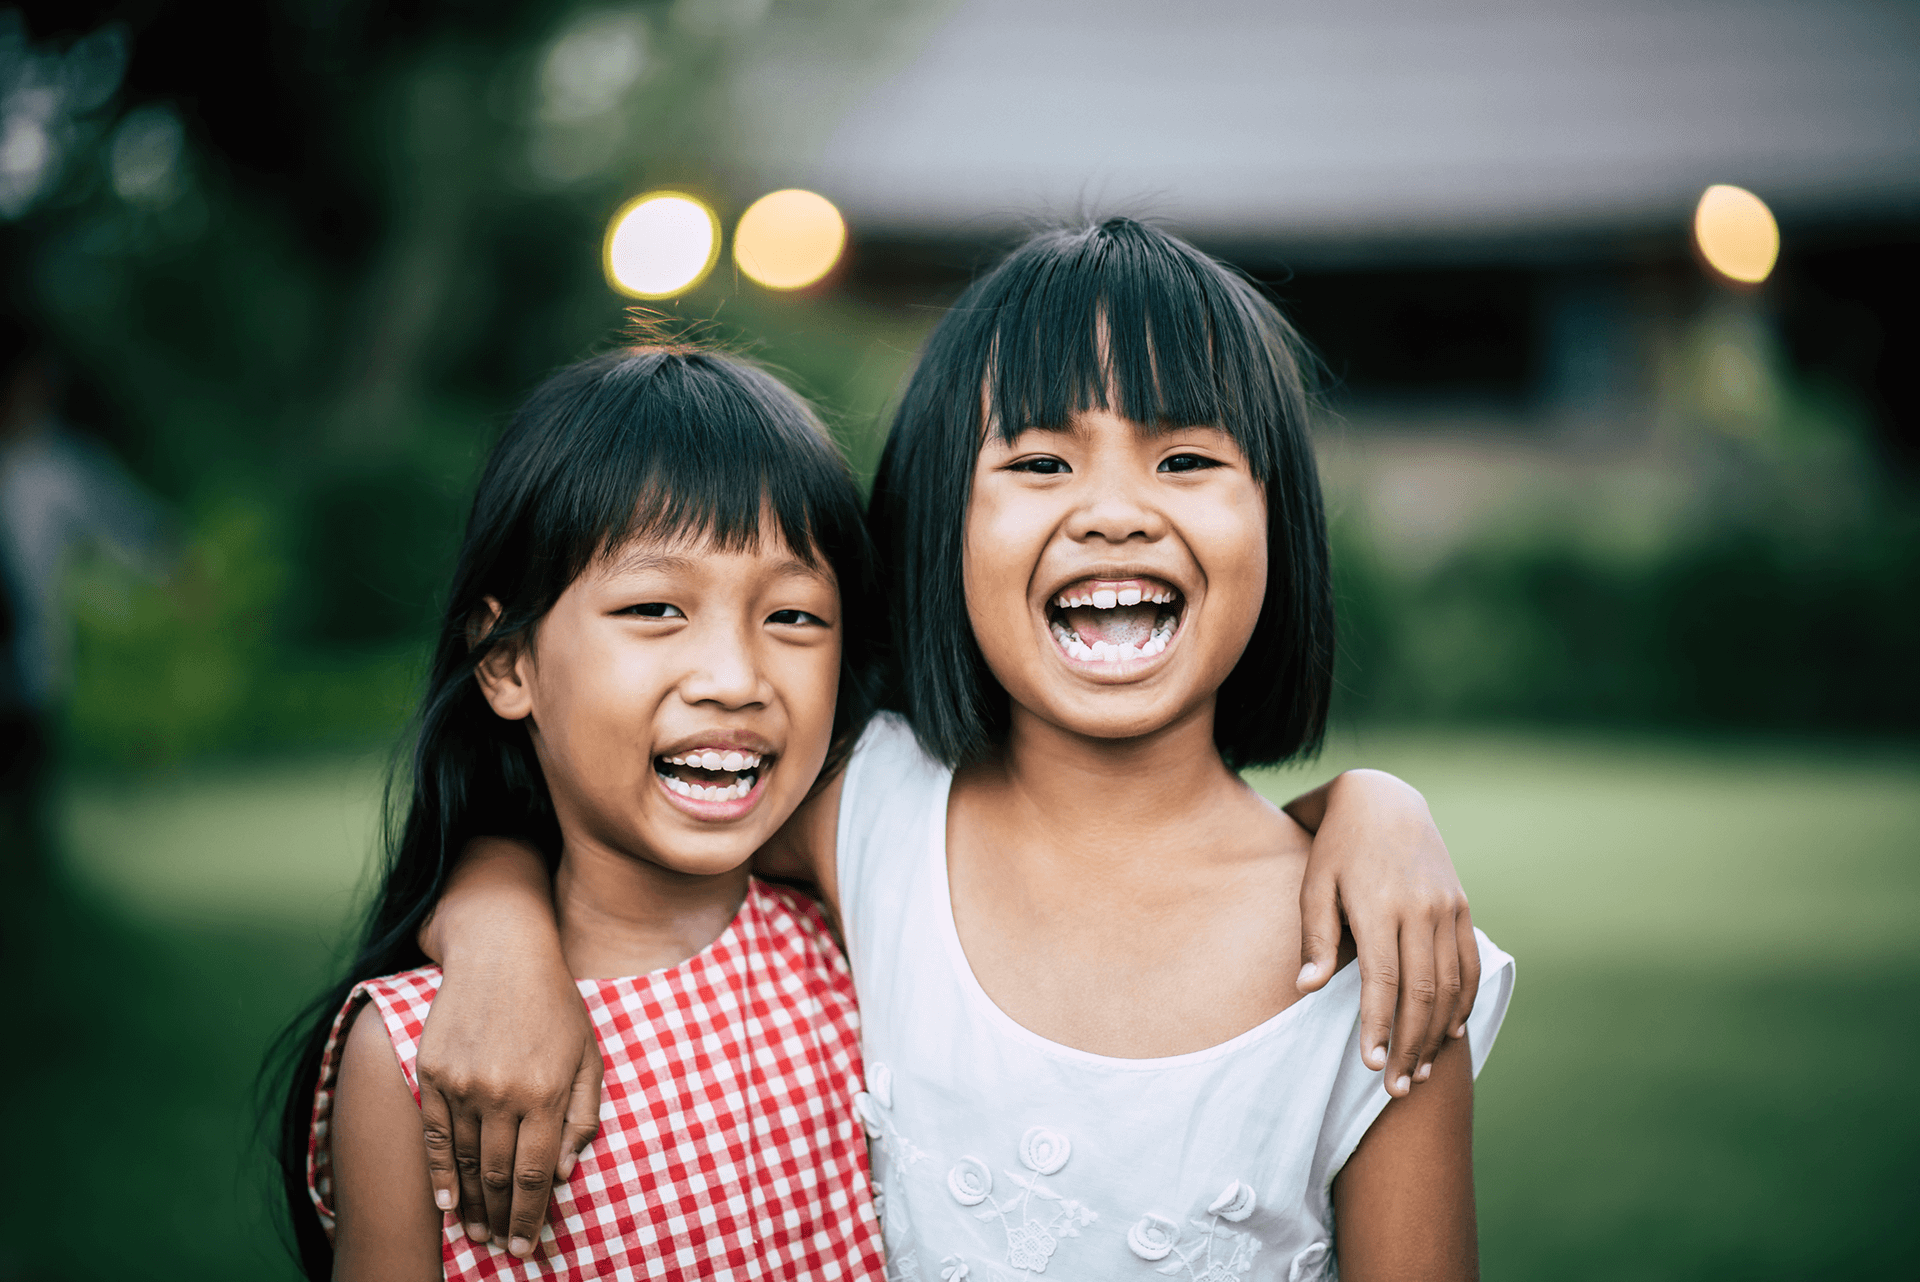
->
[760,0,1920,253]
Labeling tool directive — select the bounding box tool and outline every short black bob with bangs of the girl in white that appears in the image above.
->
[870,219,1334,770]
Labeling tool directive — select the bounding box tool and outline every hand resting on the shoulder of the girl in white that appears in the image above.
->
[1286,770,1480,1096]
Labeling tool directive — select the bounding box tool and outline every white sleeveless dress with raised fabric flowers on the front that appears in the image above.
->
[837,718,1513,1282]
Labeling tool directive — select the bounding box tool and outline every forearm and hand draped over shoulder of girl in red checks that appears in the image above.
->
[417,837,601,1257]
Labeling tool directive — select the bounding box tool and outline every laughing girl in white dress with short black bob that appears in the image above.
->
[412,219,1511,1280]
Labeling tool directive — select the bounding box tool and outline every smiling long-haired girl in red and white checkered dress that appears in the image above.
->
[278,347,881,1278]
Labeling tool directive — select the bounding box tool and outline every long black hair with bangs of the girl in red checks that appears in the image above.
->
[269,347,874,1278]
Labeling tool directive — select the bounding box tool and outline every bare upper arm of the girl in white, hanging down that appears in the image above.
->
[1332,1038,1480,1282]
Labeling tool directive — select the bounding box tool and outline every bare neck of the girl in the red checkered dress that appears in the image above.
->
[553,833,749,979]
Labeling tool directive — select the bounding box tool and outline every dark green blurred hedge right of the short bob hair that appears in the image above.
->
[1334,510,1920,733]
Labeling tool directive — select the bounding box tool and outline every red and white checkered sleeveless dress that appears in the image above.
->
[307,881,883,1280]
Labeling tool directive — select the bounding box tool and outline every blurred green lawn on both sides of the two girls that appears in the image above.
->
[0,731,1920,1282]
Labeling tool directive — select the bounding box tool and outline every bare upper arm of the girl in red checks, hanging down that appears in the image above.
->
[330,1006,444,1282]
